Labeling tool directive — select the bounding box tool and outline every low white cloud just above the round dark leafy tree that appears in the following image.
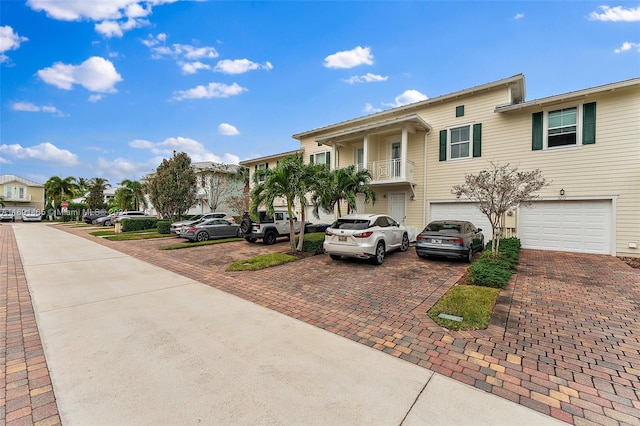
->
[129,136,240,164]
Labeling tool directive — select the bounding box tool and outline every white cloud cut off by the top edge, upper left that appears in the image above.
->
[27,0,177,37]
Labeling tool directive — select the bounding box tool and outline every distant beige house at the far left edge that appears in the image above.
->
[0,175,44,218]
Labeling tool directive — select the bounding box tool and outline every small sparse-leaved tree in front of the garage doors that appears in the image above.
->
[452,162,548,256]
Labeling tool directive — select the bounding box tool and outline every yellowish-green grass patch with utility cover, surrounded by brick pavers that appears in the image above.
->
[429,285,500,330]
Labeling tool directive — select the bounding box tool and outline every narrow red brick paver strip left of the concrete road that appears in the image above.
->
[0,225,61,426]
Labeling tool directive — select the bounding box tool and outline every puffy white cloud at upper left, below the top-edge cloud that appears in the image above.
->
[38,56,122,93]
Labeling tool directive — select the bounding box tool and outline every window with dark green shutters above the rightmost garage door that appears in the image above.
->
[531,102,596,151]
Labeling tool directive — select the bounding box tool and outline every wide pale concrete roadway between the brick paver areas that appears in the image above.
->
[13,223,561,425]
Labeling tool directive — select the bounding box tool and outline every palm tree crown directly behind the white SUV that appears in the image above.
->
[312,165,377,217]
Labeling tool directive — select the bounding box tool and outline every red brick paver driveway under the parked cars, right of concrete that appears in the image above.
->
[31,227,640,425]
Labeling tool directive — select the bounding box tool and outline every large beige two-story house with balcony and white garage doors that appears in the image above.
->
[243,74,640,257]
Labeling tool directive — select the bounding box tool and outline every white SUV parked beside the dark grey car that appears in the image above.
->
[323,214,409,265]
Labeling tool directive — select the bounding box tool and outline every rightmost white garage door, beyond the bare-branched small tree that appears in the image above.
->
[518,200,613,254]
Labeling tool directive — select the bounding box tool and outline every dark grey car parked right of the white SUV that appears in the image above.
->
[416,220,484,262]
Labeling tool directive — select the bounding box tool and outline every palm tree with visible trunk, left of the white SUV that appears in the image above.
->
[250,155,309,253]
